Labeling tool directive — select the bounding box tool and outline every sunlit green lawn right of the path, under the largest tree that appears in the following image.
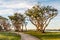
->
[24,31,60,40]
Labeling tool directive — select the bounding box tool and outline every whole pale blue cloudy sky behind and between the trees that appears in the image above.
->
[0,0,60,29]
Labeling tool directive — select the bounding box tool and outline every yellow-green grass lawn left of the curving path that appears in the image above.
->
[0,32,21,40]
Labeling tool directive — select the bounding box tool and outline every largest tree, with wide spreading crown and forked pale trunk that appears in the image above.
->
[25,5,58,32]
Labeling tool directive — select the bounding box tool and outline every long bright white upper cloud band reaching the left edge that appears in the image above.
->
[0,3,32,8]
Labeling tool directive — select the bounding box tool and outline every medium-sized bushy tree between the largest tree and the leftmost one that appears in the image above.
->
[9,13,25,31]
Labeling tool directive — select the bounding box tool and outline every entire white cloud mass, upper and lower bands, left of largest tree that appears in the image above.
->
[0,1,32,16]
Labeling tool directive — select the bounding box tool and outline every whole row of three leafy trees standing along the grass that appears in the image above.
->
[0,5,58,32]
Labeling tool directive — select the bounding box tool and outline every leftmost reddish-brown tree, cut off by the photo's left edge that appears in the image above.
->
[0,16,10,31]
